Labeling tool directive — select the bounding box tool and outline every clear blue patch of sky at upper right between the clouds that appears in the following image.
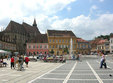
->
[56,0,113,19]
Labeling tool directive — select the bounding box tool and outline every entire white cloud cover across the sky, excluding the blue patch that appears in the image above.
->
[0,0,113,39]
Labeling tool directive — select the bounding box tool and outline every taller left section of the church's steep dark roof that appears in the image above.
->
[3,21,26,34]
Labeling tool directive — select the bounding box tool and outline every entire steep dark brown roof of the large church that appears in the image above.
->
[3,21,41,35]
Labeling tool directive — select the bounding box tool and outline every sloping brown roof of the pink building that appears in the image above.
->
[28,34,48,43]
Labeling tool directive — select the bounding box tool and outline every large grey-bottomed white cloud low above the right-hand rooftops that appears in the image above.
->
[51,14,113,39]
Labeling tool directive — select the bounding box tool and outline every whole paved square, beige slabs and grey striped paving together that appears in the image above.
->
[0,55,113,83]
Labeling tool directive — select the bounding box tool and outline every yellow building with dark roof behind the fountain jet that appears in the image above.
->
[47,30,77,55]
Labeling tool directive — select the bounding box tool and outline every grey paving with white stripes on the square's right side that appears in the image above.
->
[28,56,113,83]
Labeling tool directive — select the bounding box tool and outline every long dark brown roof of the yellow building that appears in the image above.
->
[47,30,75,36]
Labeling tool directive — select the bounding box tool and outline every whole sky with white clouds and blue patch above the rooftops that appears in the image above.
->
[0,0,113,40]
